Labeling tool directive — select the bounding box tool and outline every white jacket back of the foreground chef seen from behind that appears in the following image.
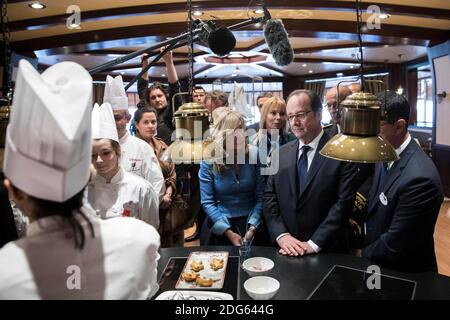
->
[0,208,160,299]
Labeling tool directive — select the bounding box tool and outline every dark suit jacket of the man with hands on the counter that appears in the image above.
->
[263,133,356,252]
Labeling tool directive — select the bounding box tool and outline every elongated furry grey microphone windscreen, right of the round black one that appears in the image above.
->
[264,19,294,66]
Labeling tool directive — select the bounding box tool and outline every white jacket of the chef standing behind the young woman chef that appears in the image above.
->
[119,132,166,197]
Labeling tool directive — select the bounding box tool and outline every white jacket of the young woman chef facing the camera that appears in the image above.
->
[88,167,159,229]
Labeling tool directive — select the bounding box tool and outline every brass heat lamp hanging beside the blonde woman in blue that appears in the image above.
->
[161,102,224,164]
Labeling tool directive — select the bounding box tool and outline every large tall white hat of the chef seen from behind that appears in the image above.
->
[3,60,92,202]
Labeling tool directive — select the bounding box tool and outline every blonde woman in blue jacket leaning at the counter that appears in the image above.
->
[199,110,264,246]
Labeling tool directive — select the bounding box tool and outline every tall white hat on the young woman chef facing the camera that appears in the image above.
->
[92,103,119,142]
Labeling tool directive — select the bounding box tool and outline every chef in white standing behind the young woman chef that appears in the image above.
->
[103,76,166,198]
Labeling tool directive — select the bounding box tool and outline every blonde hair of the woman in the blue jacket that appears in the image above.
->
[212,108,248,174]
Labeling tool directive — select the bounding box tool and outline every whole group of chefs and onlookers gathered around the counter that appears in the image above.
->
[0,48,443,299]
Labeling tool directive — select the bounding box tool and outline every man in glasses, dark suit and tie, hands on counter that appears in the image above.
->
[263,90,356,256]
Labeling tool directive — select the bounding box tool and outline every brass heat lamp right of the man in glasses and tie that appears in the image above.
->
[320,92,399,163]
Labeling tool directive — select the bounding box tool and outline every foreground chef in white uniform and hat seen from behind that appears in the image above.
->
[0,60,159,299]
